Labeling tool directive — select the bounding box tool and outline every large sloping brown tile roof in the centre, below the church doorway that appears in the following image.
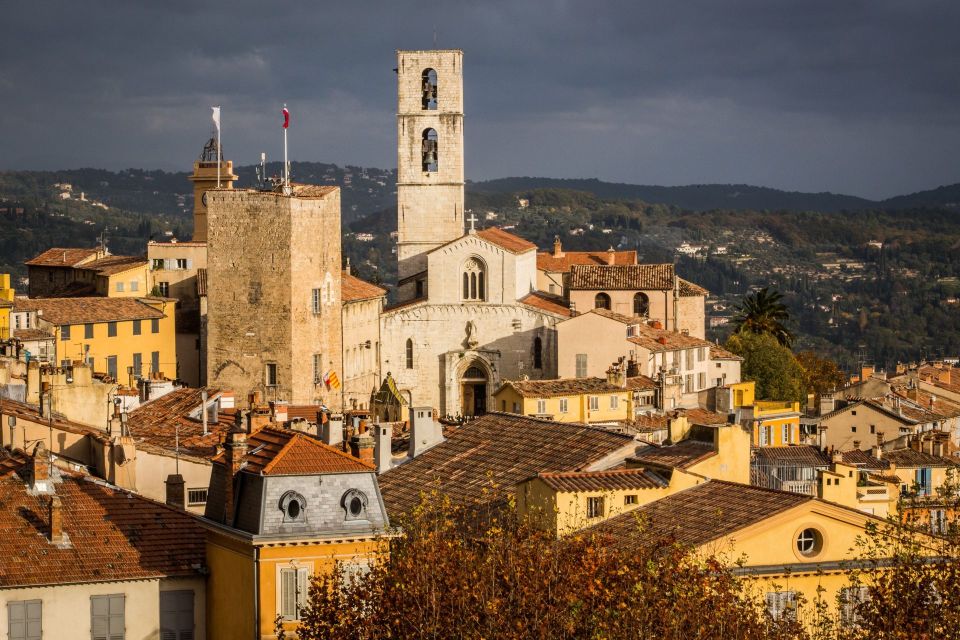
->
[378,412,633,514]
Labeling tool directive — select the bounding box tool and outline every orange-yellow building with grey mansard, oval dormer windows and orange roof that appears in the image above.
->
[202,426,389,640]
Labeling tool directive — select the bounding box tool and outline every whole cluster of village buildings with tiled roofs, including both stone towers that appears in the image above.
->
[0,50,960,640]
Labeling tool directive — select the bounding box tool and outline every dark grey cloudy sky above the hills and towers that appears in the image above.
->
[0,0,960,199]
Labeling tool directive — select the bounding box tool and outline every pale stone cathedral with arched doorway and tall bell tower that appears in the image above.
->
[380,50,570,416]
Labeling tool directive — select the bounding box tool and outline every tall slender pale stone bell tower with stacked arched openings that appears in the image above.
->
[397,49,463,300]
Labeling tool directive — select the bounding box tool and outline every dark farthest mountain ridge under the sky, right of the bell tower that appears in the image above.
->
[467,177,960,213]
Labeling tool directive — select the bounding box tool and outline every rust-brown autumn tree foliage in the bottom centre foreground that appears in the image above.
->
[299,495,803,640]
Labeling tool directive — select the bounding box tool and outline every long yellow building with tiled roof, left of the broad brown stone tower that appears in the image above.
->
[14,298,177,382]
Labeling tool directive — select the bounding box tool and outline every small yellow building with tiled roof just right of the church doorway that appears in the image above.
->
[493,377,653,424]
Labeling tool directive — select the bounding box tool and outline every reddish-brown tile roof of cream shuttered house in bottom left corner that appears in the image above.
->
[0,458,205,588]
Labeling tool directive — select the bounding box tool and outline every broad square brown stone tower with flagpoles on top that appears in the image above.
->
[207,184,344,410]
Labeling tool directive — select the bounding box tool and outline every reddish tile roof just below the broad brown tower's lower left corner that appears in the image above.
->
[127,388,233,460]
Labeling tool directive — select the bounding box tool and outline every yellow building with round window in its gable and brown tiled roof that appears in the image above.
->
[591,480,936,624]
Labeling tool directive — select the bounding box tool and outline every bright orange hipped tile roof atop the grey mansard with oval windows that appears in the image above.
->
[214,426,375,476]
